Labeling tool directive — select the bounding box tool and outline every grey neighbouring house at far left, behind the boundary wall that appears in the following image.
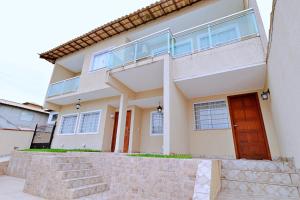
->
[0,99,49,130]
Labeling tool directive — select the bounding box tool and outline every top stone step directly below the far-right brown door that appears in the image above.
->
[222,160,295,173]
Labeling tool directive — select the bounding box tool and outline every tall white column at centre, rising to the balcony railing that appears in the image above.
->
[163,56,172,154]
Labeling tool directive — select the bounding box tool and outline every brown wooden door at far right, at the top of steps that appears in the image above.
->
[228,93,271,160]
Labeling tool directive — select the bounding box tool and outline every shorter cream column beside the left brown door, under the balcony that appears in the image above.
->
[115,94,128,153]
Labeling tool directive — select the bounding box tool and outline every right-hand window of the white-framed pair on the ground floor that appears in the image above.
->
[78,111,101,133]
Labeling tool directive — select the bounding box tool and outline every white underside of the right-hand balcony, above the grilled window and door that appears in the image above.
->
[174,64,266,98]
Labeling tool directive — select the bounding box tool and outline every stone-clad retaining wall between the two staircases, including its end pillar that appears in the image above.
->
[85,154,220,200]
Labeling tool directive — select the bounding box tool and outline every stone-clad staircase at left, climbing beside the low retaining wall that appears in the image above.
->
[56,157,108,199]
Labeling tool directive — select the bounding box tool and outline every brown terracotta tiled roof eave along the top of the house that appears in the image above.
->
[40,0,201,63]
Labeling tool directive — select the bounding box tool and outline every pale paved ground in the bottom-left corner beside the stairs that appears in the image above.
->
[0,176,43,200]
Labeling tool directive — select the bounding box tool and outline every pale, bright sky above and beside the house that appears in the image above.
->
[0,0,272,104]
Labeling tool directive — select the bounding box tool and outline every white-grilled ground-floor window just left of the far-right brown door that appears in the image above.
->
[194,100,229,130]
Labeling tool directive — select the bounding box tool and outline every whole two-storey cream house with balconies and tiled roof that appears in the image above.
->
[41,0,281,159]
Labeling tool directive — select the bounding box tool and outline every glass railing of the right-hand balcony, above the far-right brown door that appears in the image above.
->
[172,9,258,57]
